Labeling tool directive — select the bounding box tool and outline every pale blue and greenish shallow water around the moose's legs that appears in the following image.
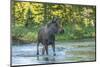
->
[12,41,95,65]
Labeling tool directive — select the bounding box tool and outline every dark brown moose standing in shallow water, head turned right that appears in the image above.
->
[37,17,64,56]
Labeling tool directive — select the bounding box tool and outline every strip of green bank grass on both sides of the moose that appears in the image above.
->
[11,26,95,43]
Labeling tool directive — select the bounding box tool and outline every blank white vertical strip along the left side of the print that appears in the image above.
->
[0,0,10,67]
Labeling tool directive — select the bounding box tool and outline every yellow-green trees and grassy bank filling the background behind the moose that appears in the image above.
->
[11,1,96,42]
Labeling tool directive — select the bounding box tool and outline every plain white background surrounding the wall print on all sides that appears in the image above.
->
[0,0,100,67]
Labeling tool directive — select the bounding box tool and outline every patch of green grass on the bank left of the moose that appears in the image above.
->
[12,26,37,42]
